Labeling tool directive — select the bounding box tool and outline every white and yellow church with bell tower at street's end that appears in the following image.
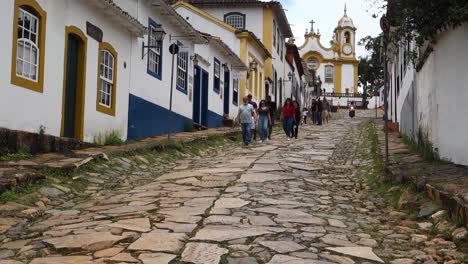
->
[299,7,359,94]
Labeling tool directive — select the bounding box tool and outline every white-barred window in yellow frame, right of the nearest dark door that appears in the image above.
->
[99,50,115,108]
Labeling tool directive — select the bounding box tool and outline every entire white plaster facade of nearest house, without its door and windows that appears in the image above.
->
[0,0,131,141]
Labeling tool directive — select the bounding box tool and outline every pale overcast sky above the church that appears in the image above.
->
[280,0,381,56]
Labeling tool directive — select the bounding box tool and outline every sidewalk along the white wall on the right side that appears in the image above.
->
[378,121,468,227]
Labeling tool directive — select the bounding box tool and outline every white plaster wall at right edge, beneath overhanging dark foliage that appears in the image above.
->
[430,23,468,165]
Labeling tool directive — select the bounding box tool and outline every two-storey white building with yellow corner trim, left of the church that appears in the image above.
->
[170,0,293,106]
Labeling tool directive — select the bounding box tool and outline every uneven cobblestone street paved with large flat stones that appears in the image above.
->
[0,112,464,264]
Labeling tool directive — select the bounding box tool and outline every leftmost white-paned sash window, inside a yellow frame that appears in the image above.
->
[16,8,39,81]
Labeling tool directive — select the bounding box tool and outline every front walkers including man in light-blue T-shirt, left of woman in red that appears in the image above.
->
[237,95,276,145]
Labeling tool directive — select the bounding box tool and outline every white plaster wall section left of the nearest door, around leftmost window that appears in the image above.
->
[0,0,65,136]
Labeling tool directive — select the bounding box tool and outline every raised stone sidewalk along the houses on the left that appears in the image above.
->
[0,127,239,194]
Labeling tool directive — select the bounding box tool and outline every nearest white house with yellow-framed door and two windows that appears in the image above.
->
[0,0,145,142]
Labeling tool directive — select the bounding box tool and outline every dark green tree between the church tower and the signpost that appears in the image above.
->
[358,34,384,107]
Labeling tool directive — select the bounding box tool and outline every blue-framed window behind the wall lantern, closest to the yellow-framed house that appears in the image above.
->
[147,18,163,80]
